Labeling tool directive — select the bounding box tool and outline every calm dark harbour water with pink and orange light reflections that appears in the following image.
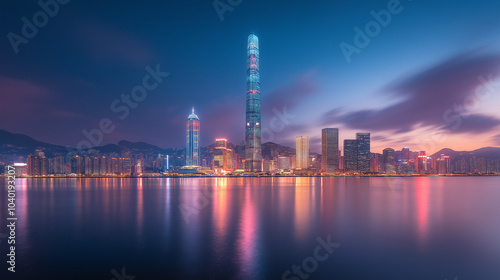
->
[0,177,500,280]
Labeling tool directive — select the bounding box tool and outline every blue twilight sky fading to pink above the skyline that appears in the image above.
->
[0,0,500,153]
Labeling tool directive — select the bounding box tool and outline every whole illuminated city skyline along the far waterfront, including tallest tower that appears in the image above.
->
[7,34,500,176]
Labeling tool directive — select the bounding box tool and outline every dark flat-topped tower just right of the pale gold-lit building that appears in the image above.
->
[321,128,339,172]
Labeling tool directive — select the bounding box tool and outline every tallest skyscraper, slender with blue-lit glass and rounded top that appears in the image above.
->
[245,34,262,172]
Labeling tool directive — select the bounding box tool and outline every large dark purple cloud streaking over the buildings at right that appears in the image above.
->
[322,52,500,133]
